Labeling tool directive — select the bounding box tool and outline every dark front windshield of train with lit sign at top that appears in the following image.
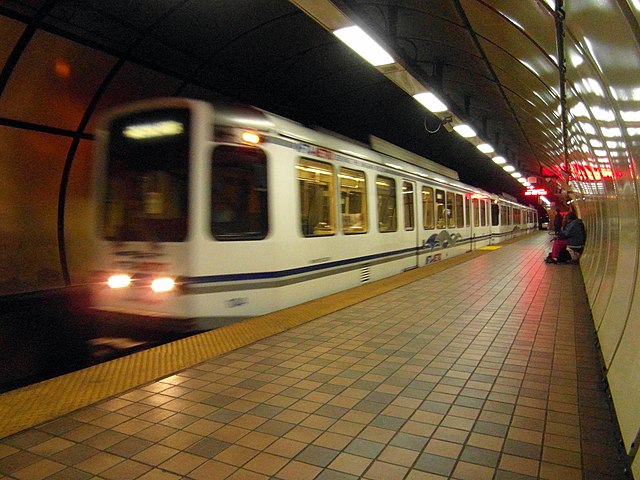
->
[102,108,189,242]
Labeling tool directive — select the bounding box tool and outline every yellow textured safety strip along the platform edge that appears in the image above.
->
[0,235,528,438]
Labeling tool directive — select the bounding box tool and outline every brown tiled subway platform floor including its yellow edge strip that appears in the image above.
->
[0,232,631,480]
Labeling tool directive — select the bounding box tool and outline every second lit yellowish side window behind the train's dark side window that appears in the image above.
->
[338,168,369,235]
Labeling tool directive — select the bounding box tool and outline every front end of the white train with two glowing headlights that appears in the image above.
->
[92,100,194,328]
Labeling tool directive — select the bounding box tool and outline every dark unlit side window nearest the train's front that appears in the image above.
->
[210,146,269,240]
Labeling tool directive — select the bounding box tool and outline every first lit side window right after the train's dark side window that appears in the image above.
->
[296,158,336,237]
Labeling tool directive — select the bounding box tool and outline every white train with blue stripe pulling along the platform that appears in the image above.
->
[92,98,537,331]
